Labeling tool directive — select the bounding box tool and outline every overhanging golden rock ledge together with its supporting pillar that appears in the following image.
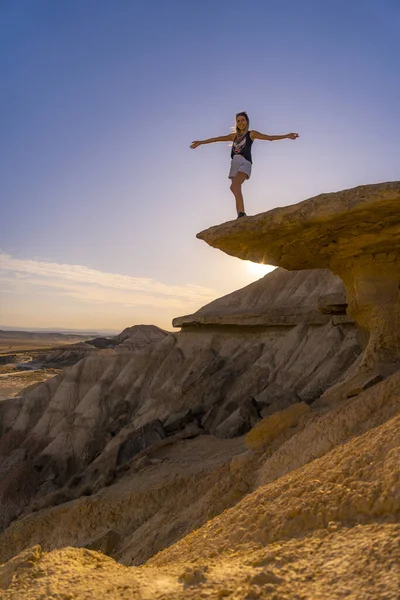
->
[197,182,400,368]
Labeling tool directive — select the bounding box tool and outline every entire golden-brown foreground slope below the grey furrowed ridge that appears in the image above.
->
[0,373,400,600]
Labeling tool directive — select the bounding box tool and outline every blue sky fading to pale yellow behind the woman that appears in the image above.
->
[0,0,400,330]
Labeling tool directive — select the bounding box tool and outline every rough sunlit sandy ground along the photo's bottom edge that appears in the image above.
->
[0,523,400,600]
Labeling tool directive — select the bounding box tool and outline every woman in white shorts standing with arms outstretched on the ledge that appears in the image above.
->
[190,112,299,219]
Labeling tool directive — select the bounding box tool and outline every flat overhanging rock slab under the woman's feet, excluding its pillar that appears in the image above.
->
[197,181,400,270]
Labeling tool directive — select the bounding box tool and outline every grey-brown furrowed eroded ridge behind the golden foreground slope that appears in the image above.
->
[0,269,361,525]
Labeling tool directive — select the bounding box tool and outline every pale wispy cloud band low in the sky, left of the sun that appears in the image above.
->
[0,252,219,308]
